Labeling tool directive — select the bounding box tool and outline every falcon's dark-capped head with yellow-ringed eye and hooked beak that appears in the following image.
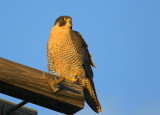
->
[54,16,72,28]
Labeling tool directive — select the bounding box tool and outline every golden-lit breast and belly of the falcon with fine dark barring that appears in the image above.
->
[48,26,85,77]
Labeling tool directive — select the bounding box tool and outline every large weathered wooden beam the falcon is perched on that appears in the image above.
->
[0,57,84,114]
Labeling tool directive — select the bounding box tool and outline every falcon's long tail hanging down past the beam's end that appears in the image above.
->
[82,78,101,113]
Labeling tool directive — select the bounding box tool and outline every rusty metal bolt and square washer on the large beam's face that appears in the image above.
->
[47,77,64,93]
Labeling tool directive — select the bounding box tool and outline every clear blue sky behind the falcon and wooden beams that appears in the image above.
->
[0,0,160,115]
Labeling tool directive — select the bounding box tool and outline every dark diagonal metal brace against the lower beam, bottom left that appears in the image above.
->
[2,100,28,115]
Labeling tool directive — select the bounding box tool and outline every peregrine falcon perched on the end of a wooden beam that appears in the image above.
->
[47,16,101,113]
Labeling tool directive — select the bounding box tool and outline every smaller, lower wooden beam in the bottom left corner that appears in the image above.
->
[0,99,37,115]
